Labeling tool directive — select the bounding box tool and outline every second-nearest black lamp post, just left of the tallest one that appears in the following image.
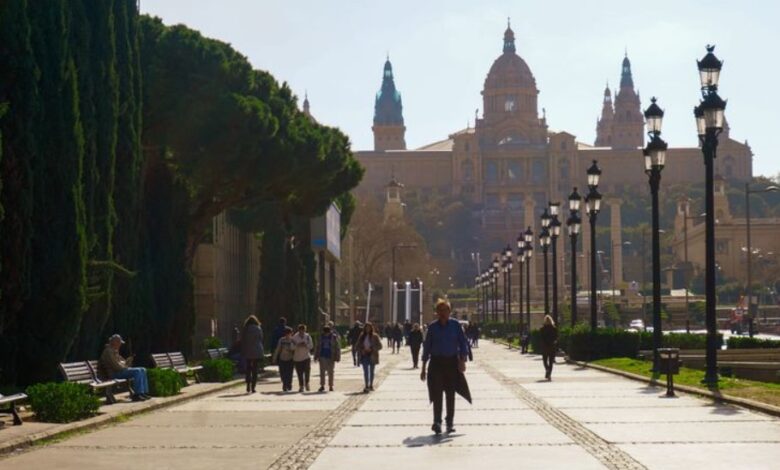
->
[643,97,668,371]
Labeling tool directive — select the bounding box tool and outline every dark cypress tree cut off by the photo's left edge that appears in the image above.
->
[0,0,37,383]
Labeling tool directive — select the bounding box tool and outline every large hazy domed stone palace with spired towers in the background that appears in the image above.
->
[356,22,752,294]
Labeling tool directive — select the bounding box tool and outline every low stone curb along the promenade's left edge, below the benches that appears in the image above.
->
[0,372,266,458]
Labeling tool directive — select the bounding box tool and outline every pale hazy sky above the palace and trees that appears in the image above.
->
[140,0,780,176]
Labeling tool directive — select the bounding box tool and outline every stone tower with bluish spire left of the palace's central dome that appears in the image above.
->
[371,58,406,151]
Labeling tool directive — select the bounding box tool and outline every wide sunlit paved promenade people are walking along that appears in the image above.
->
[0,341,780,470]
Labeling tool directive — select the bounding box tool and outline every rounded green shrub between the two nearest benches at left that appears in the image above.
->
[26,382,100,423]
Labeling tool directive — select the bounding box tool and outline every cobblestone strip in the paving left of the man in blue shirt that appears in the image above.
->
[268,356,400,470]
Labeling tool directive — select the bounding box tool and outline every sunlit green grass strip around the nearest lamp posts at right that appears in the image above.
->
[592,357,780,406]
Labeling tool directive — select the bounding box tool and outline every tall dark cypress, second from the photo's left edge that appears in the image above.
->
[18,0,87,384]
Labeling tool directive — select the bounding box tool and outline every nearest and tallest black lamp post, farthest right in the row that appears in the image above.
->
[694,46,726,385]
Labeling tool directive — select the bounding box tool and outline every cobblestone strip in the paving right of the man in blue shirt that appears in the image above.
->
[477,360,647,470]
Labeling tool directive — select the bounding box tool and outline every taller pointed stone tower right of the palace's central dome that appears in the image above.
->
[612,55,645,149]
